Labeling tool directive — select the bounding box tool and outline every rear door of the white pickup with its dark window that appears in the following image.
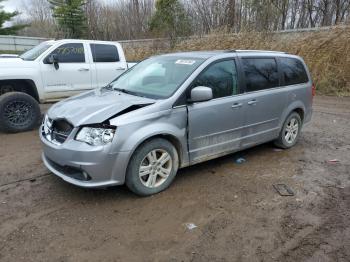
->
[90,43,127,87]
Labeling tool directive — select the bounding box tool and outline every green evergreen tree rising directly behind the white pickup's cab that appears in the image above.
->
[48,0,86,38]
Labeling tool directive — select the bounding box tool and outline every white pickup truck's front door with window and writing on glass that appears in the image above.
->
[40,43,92,98]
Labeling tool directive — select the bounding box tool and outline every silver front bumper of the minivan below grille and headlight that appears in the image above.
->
[40,132,129,188]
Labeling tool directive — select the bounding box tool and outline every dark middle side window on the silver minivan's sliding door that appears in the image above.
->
[242,58,279,92]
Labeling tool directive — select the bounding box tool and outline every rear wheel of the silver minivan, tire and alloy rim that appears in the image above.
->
[274,112,302,149]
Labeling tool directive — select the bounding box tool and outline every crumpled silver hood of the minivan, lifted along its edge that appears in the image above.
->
[48,89,155,126]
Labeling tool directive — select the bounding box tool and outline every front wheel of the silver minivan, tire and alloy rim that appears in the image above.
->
[125,138,179,196]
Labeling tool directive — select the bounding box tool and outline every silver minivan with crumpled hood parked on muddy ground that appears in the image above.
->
[40,50,315,196]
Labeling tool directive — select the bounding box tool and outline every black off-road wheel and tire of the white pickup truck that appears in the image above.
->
[0,92,41,133]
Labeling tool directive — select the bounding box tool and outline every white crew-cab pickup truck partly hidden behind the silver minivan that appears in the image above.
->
[0,39,134,132]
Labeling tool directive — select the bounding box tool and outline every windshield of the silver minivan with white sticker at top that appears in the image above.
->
[109,56,204,99]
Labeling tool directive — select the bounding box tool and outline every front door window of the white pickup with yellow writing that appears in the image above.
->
[51,43,85,63]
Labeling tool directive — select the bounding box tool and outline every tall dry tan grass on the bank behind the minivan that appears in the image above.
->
[126,27,350,96]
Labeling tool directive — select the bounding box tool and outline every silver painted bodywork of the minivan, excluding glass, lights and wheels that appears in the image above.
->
[40,51,312,187]
